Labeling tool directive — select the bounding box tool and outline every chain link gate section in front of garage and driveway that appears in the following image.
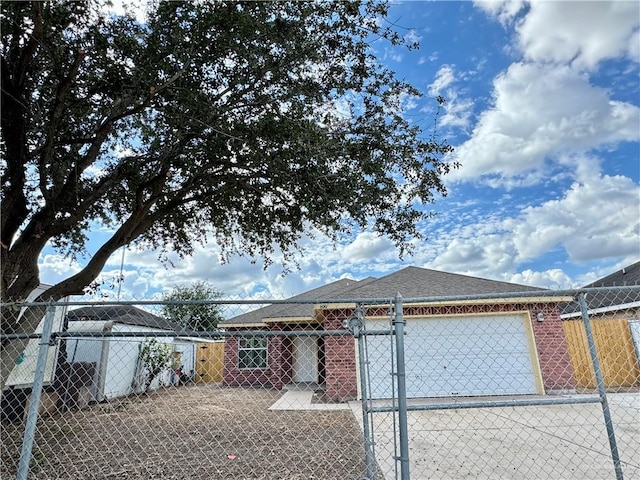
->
[358,287,640,480]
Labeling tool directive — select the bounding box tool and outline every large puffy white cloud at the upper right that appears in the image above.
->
[456,0,640,188]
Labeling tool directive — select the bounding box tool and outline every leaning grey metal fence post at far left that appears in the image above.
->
[16,305,56,480]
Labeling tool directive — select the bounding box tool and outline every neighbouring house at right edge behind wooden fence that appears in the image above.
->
[561,262,640,390]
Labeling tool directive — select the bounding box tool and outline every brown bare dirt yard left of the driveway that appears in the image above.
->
[0,385,365,480]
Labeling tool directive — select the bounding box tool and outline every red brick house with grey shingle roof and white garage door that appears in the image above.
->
[221,267,575,400]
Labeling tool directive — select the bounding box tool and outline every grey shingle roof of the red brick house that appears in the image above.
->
[220,267,543,327]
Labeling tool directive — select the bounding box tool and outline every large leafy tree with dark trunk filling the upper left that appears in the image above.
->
[0,0,456,386]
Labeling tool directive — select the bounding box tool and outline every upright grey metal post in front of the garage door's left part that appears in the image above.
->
[393,293,410,480]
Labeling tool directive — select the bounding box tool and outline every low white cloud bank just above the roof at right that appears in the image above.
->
[429,171,640,288]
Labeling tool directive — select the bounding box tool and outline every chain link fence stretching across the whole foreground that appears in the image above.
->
[0,287,640,479]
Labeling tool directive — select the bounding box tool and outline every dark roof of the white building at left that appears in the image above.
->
[67,305,181,331]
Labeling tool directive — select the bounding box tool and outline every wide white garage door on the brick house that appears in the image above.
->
[367,315,538,398]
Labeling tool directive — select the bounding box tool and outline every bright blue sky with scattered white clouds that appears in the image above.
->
[40,1,640,299]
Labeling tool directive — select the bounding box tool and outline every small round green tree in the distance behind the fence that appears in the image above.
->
[162,281,224,332]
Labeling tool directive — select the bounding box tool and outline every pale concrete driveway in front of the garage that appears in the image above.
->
[350,393,640,480]
